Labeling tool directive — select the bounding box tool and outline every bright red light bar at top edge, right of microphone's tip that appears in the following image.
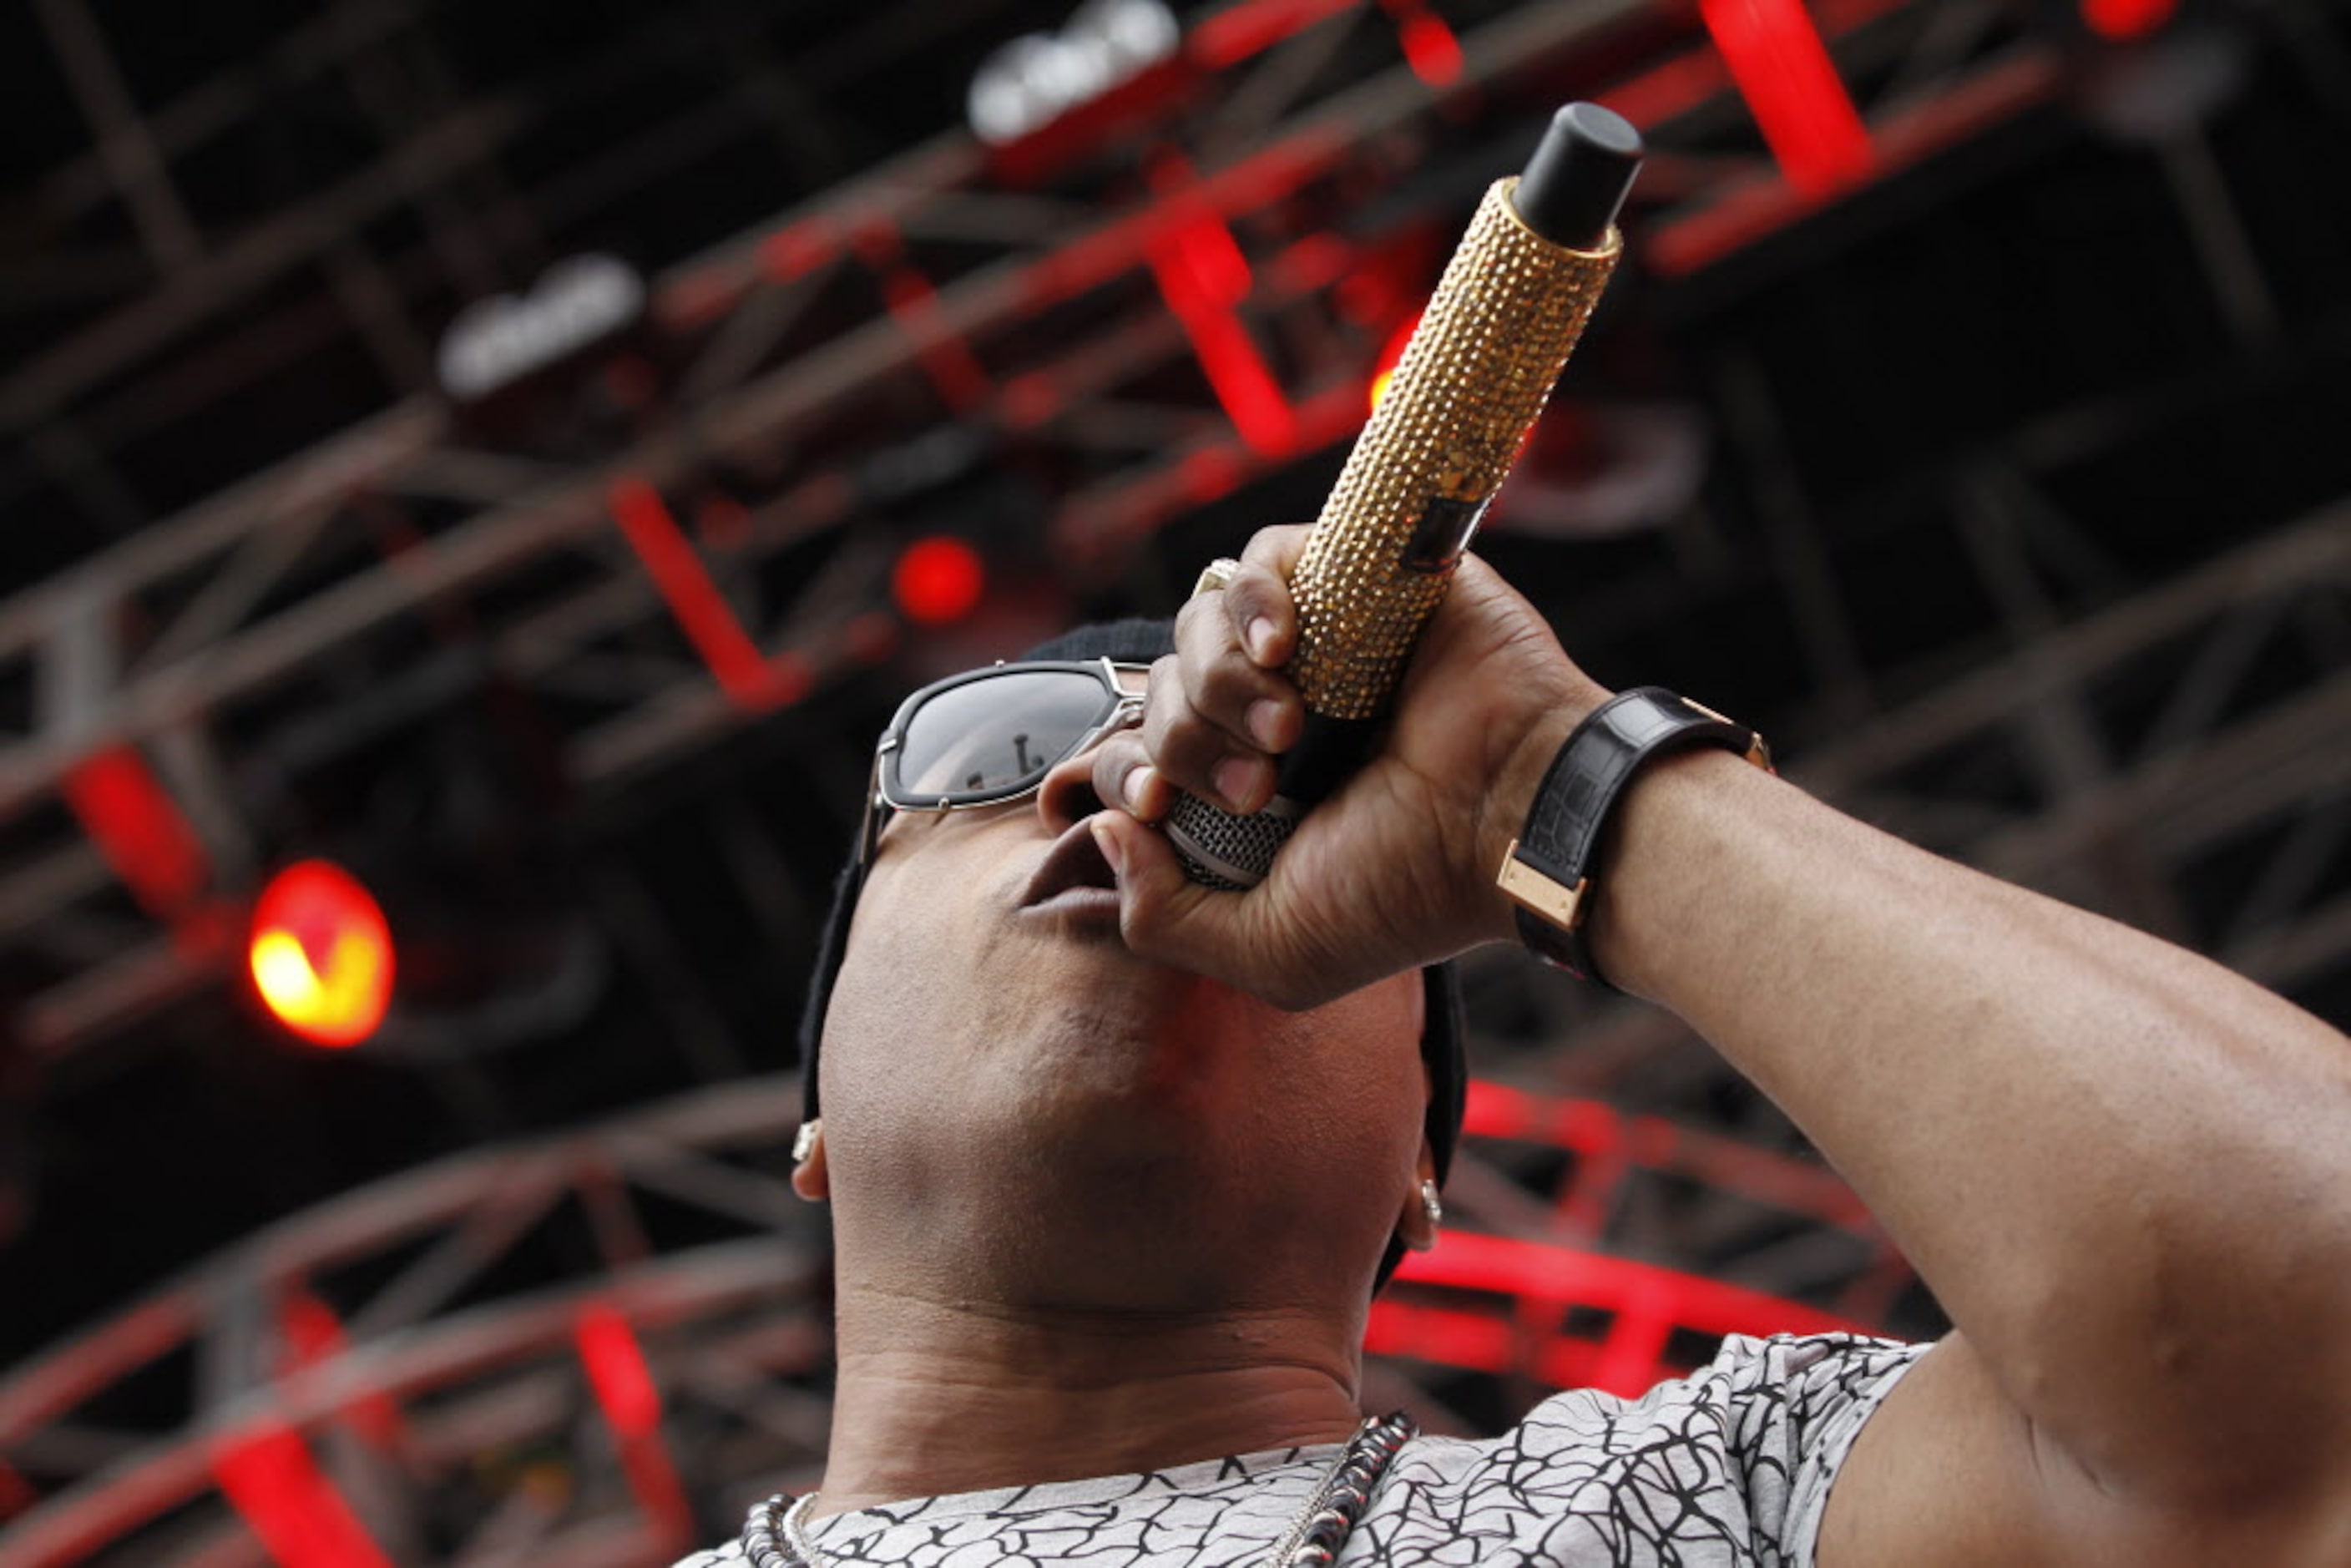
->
[1697,0,1872,198]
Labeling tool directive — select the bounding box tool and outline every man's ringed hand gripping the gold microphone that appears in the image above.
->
[1093,527,1608,1006]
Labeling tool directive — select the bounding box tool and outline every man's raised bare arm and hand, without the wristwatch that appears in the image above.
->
[1095,531,2351,1568]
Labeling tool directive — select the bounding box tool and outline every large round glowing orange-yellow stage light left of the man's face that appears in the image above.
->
[245,861,392,1046]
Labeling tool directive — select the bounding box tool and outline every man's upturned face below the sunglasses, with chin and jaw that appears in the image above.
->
[821,667,1427,1305]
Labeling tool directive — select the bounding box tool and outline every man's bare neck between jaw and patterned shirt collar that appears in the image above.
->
[813,1295,1361,1516]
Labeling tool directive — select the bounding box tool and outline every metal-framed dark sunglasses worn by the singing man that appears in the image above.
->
[858,658,1150,867]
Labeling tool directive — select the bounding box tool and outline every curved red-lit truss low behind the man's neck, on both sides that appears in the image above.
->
[0,1079,1909,1568]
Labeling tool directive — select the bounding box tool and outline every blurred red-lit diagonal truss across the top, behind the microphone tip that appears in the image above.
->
[0,0,2294,1058]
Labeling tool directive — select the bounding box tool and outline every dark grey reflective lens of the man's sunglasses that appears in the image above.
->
[896,670,1110,802]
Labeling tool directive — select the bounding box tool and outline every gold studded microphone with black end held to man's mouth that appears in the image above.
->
[1164,104,1641,891]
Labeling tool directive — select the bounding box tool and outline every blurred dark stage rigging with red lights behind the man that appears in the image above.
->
[0,0,2351,1568]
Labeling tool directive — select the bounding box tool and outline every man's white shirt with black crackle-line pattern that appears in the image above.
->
[677,1335,1925,1568]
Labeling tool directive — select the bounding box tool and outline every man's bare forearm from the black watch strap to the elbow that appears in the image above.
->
[1594,755,2351,1502]
